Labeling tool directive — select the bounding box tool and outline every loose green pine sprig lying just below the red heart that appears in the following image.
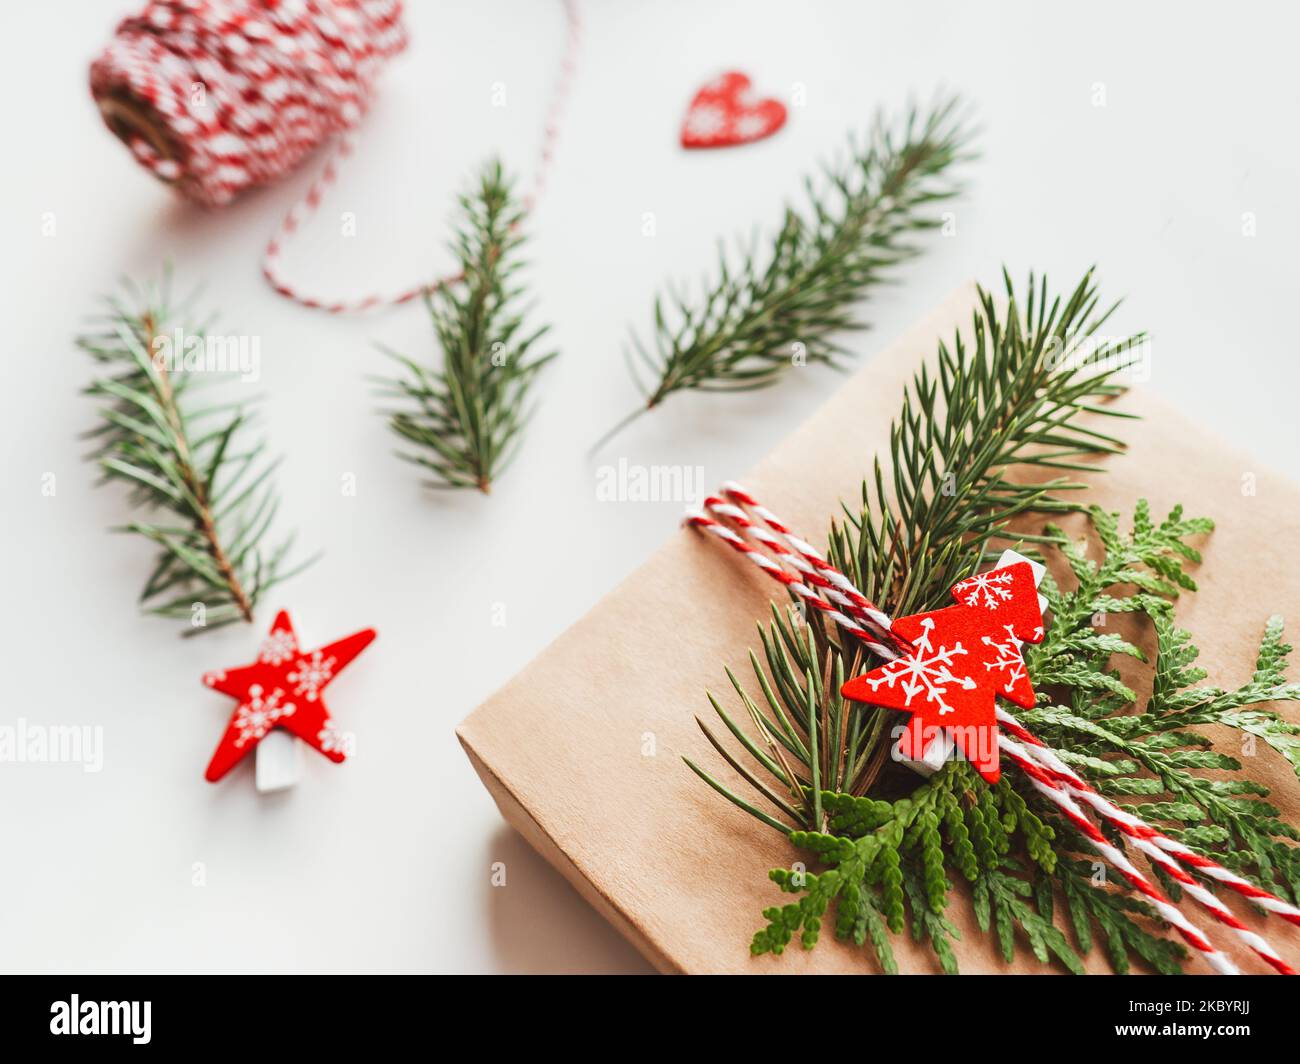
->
[595,90,971,446]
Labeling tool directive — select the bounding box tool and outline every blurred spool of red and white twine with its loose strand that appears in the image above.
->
[98,0,581,313]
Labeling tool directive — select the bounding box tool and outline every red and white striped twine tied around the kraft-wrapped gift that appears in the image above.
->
[686,483,1300,976]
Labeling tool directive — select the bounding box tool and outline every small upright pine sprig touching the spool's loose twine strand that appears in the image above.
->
[382,161,556,493]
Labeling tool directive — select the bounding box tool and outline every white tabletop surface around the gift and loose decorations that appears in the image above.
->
[0,0,1300,972]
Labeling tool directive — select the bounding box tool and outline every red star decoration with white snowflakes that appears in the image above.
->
[203,610,374,783]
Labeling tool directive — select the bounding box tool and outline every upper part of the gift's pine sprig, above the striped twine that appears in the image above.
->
[831,271,1147,615]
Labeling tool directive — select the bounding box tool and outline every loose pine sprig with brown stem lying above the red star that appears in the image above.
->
[78,271,303,635]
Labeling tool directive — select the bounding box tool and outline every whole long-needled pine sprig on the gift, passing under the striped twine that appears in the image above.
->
[702,271,1144,827]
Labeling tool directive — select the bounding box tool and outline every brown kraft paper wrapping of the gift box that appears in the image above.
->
[458,285,1300,974]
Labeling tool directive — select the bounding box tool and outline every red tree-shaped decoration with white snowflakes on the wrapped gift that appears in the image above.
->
[841,562,1043,783]
